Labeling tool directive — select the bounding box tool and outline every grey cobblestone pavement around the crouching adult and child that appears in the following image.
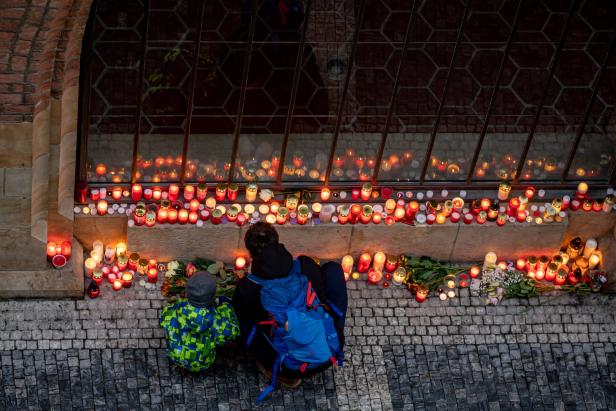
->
[0,282,616,410]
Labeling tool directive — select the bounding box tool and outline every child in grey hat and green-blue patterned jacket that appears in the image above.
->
[160,272,239,372]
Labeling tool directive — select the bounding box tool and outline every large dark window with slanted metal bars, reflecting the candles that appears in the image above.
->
[78,0,616,188]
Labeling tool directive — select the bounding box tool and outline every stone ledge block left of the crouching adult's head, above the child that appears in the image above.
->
[127,224,240,262]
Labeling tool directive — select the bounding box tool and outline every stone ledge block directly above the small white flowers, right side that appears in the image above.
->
[451,220,567,261]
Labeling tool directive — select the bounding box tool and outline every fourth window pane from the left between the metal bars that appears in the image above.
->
[234,2,304,181]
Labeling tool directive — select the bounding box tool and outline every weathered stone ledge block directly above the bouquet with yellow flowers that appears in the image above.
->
[350,223,459,260]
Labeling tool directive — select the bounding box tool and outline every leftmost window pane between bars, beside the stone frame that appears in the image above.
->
[84,1,144,182]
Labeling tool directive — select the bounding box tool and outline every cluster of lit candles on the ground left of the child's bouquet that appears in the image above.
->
[84,241,164,291]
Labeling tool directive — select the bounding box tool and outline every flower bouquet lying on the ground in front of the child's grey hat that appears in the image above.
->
[161,258,235,299]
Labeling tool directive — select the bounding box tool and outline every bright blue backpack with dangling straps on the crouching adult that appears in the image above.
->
[247,260,342,402]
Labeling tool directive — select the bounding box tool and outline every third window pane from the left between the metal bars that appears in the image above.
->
[186,1,250,181]
